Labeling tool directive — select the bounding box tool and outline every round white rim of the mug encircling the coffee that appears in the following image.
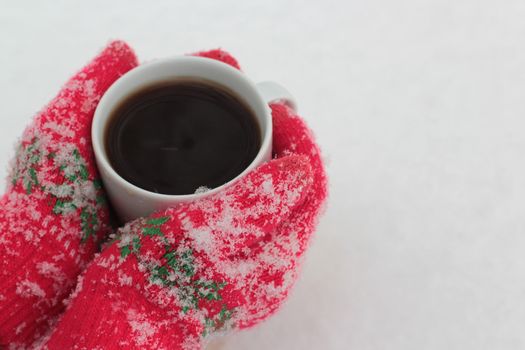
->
[91,56,273,201]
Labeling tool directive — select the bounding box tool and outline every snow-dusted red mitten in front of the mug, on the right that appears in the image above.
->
[44,51,326,349]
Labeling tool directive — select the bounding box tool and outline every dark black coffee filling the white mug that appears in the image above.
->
[105,81,261,194]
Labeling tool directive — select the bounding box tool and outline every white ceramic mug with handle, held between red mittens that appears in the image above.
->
[91,56,296,222]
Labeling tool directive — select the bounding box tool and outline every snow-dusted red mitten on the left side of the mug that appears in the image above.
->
[0,41,137,349]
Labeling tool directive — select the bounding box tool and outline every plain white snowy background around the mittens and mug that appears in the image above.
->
[0,0,525,350]
